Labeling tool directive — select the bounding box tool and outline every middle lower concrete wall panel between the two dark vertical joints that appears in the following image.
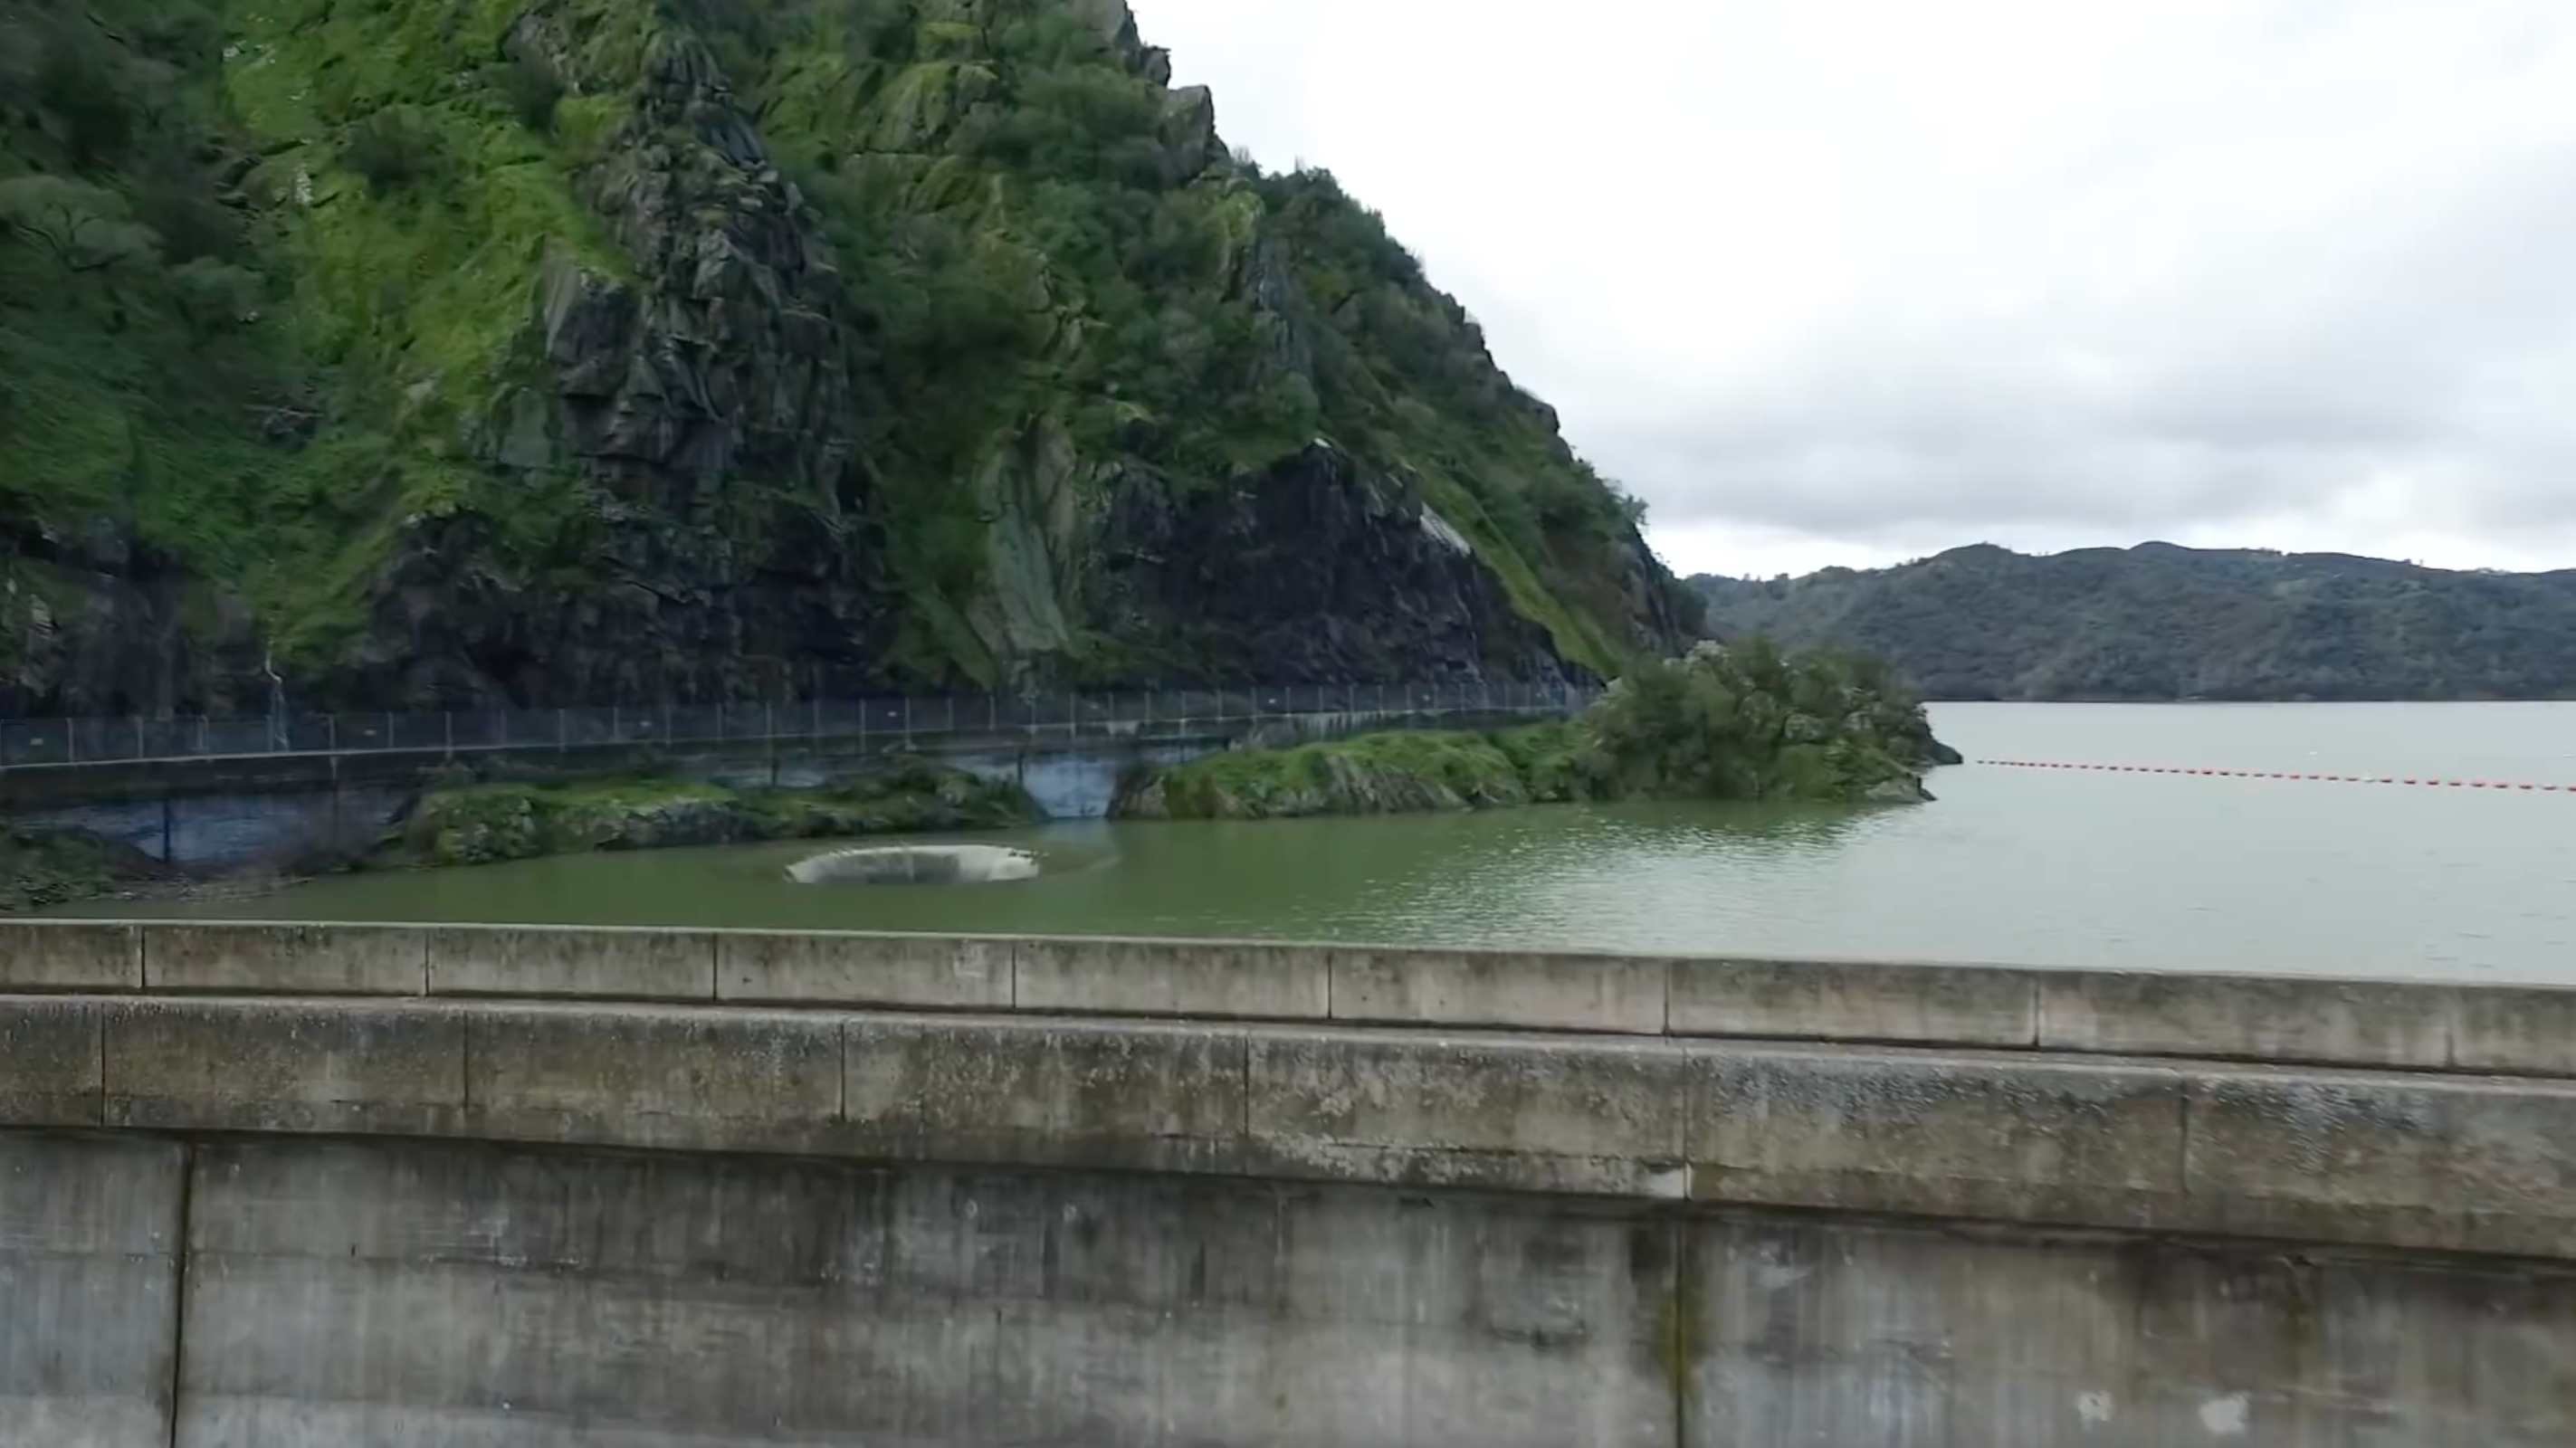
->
[177,1144,1677,1448]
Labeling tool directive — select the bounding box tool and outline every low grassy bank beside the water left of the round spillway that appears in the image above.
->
[374,763,1038,866]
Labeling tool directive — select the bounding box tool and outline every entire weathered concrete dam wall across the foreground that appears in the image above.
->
[14,925,2576,1448]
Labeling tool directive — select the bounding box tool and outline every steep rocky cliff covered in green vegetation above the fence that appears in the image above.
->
[0,0,1698,711]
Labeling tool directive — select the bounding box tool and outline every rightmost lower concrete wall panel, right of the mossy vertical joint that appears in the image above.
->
[1682,1216,2576,1448]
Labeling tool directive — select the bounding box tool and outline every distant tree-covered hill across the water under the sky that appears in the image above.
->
[1690,544,2576,700]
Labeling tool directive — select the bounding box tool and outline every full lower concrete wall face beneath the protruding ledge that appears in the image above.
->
[14,1131,2576,1448]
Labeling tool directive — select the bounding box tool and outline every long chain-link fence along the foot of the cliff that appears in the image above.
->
[0,682,1598,770]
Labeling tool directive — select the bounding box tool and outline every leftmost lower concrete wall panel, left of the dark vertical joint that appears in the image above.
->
[0,1134,183,1448]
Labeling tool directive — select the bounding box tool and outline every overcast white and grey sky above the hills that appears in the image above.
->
[1131,0,2576,575]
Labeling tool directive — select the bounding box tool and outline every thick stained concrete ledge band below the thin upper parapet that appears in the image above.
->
[14,995,2576,1260]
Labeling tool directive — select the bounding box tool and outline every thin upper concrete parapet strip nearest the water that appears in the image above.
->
[14,919,2576,1077]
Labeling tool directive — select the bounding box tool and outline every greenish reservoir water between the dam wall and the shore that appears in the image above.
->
[75,703,2576,982]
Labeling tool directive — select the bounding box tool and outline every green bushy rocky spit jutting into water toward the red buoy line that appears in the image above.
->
[1118,639,1958,819]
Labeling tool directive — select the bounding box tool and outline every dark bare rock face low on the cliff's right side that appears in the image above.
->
[1092,443,1584,682]
